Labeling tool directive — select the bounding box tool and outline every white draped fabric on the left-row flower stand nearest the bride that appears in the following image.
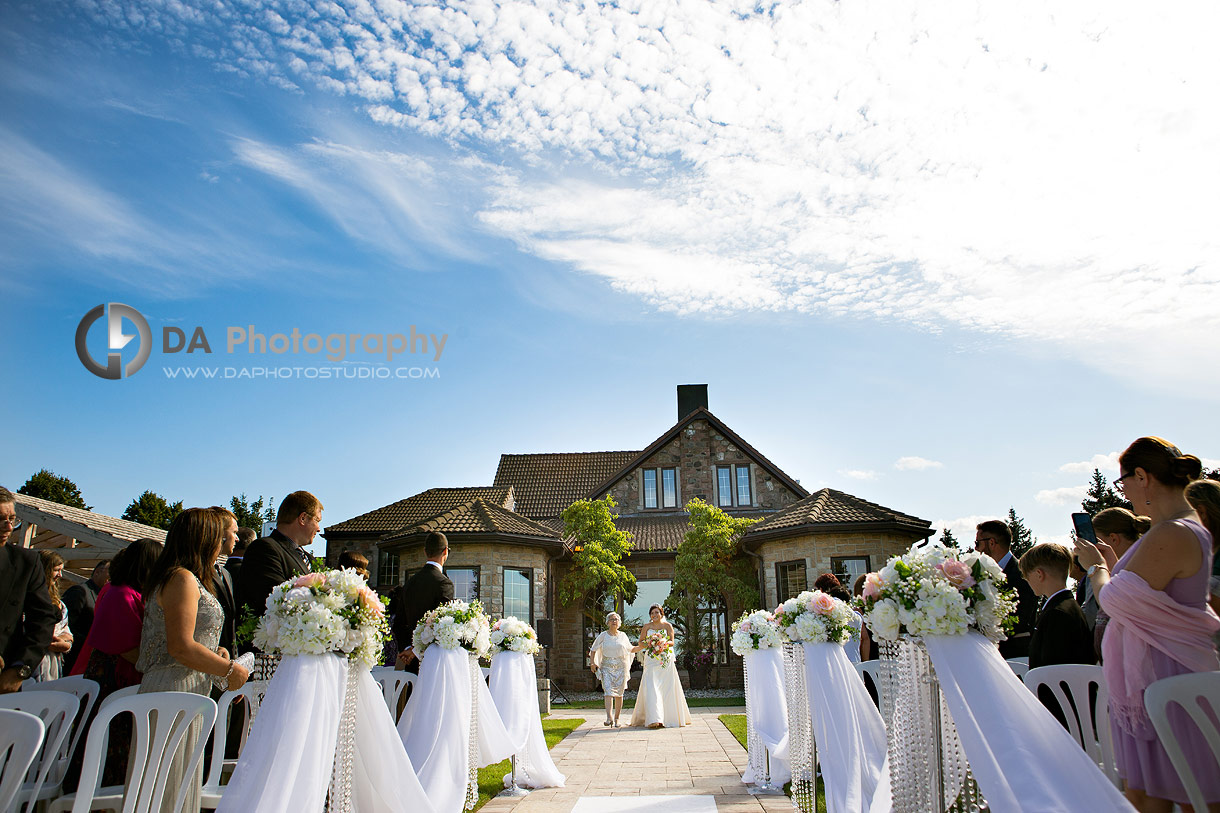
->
[492,652,564,787]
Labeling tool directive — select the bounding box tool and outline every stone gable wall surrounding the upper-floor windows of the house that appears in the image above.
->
[608,419,800,514]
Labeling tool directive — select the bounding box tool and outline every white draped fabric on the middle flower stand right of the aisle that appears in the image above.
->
[800,643,891,813]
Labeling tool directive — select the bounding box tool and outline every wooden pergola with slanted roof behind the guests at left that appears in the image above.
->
[9,494,165,581]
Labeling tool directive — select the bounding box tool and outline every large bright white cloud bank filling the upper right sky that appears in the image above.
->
[66,0,1220,377]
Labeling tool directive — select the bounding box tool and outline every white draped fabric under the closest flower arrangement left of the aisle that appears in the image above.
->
[217,654,433,813]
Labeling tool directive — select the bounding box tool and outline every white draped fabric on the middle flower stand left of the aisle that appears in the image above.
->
[398,645,514,813]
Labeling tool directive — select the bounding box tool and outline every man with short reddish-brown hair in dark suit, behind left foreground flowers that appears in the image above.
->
[237,491,322,615]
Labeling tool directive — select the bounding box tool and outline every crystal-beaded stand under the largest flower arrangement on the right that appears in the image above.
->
[883,635,988,813]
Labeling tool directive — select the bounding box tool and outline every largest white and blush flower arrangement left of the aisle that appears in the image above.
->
[254,570,389,669]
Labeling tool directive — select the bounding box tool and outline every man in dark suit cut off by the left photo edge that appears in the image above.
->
[0,486,60,695]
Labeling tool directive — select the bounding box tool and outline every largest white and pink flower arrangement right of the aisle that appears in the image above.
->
[861,546,1016,642]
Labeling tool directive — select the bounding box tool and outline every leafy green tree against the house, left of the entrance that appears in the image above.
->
[559,496,636,607]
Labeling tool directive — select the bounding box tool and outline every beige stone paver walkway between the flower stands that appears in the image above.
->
[482,706,793,813]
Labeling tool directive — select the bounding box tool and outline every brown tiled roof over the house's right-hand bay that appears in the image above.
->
[745,488,932,547]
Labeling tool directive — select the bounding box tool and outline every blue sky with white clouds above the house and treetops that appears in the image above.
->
[0,0,1220,554]
